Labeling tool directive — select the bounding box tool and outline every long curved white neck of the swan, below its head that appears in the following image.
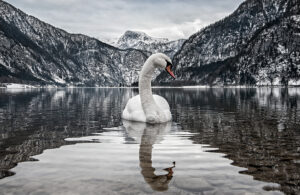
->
[139,59,156,114]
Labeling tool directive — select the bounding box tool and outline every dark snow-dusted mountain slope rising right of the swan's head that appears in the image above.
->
[157,0,300,85]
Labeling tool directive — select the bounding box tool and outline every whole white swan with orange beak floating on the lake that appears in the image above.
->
[122,53,175,123]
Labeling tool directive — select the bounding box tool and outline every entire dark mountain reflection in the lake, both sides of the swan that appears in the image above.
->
[0,88,300,194]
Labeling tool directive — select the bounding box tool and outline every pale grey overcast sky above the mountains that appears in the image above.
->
[7,0,244,41]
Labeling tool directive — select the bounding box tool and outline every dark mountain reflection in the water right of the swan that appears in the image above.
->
[156,88,300,194]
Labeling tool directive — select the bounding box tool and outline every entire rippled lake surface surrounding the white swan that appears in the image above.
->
[0,88,300,194]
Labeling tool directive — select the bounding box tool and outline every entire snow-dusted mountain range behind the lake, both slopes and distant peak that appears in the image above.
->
[0,0,300,86]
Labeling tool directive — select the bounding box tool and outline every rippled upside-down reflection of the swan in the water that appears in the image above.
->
[123,120,175,191]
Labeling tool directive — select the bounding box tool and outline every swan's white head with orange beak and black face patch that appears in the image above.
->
[151,53,175,79]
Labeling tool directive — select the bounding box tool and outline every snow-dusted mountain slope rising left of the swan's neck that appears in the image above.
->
[0,1,150,86]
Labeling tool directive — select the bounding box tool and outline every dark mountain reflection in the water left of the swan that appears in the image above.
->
[0,89,129,178]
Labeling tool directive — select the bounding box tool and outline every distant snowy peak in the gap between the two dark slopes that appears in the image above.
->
[114,31,185,58]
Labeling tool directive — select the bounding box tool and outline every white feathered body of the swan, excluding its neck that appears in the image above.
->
[122,95,172,122]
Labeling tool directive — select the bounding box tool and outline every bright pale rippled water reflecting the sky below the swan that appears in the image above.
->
[0,123,279,194]
